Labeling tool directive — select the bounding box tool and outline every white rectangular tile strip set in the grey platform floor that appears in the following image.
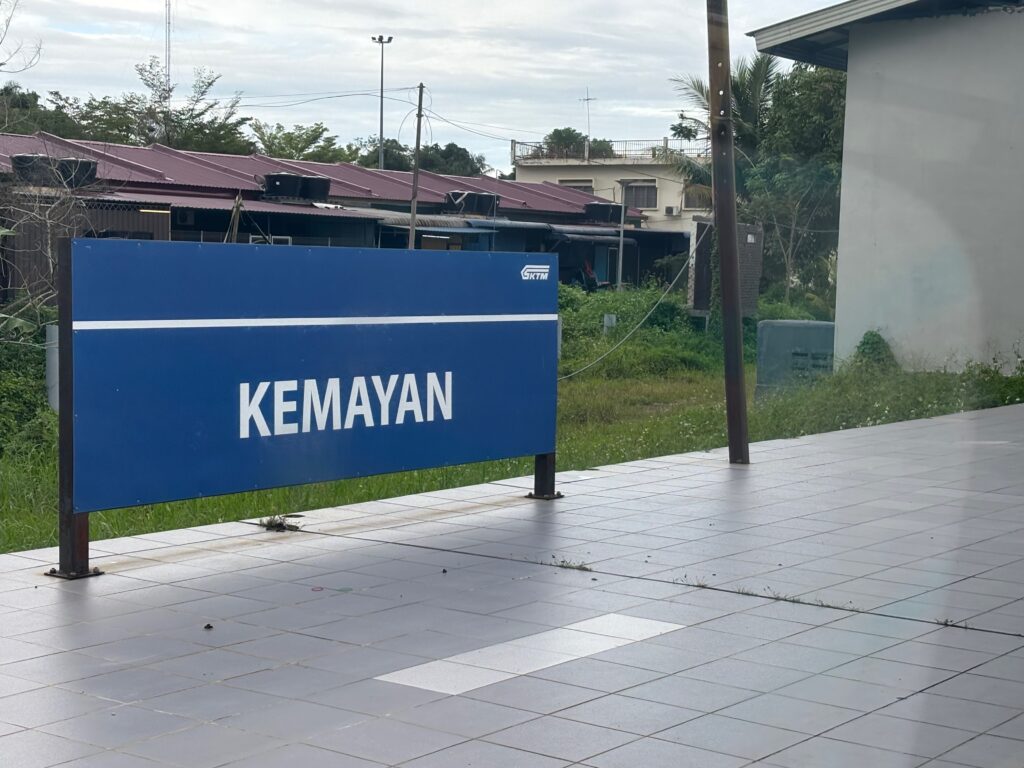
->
[375,613,685,695]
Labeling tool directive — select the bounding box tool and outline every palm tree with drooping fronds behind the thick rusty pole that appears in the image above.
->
[672,53,779,208]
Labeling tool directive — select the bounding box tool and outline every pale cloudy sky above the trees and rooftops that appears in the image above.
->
[8,0,835,168]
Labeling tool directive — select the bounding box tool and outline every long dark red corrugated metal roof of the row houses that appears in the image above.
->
[0,133,642,217]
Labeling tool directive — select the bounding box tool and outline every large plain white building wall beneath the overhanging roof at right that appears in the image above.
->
[836,12,1024,369]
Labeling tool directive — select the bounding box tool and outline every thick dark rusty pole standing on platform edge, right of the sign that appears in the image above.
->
[708,0,751,464]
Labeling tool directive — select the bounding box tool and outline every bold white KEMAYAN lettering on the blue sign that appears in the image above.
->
[239,371,452,440]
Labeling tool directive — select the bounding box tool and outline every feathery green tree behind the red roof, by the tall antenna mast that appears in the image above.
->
[50,56,255,155]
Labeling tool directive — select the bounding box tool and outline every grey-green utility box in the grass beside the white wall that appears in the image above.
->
[755,321,836,397]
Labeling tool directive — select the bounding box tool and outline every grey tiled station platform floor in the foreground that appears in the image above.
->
[0,407,1024,768]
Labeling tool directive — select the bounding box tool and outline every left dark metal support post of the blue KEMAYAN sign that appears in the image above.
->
[48,240,100,579]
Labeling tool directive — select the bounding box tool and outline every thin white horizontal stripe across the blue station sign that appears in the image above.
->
[72,314,558,331]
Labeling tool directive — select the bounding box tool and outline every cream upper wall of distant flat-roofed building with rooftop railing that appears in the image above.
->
[515,160,703,232]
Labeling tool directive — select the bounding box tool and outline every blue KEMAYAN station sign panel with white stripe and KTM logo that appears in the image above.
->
[72,240,558,512]
